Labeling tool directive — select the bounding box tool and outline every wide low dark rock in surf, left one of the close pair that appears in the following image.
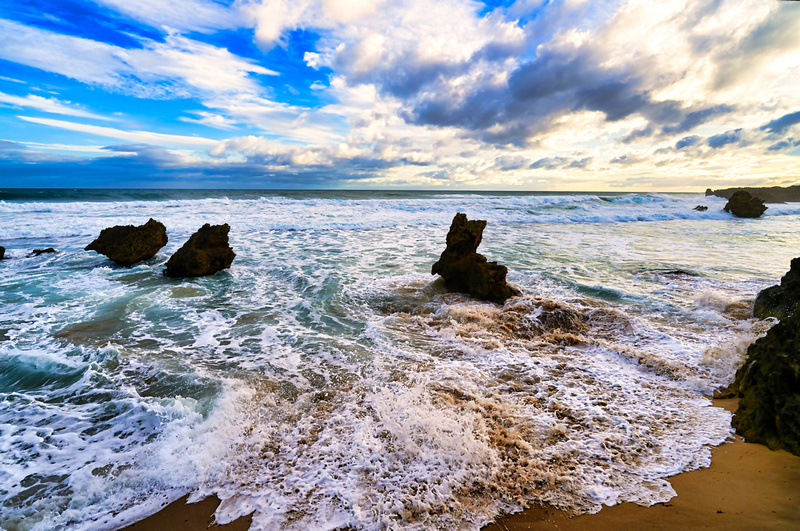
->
[84,218,169,266]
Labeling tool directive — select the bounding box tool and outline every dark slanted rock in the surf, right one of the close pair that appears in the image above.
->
[164,223,236,277]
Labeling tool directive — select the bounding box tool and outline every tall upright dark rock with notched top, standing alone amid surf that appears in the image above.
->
[431,212,520,302]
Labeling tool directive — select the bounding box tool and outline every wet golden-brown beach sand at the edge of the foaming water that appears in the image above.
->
[122,398,800,531]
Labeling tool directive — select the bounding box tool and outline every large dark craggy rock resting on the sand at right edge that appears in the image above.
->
[732,308,800,455]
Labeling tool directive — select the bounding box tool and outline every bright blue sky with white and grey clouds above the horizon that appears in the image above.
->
[0,0,800,191]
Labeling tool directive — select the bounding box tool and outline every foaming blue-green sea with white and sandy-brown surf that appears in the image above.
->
[0,190,800,531]
